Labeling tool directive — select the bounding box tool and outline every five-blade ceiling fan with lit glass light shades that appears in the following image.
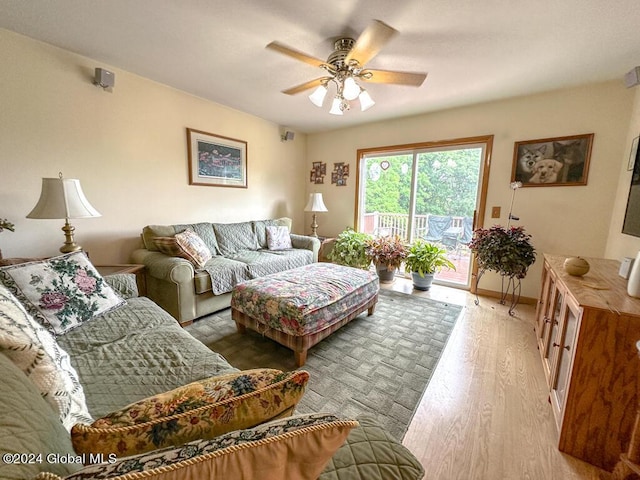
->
[266,20,427,115]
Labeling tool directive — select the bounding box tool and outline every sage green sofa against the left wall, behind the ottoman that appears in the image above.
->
[131,218,320,325]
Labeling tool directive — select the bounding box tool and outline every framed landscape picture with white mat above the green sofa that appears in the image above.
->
[187,128,247,188]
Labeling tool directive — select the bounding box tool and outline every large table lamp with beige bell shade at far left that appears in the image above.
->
[27,173,101,253]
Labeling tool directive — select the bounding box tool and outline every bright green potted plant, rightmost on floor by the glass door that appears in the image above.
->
[404,239,456,290]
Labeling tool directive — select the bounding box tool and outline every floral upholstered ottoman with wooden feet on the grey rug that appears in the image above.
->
[231,263,380,367]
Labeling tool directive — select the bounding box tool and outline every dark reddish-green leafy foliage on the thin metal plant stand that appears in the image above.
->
[469,225,536,278]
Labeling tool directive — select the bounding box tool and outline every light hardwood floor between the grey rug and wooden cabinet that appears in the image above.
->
[383,278,602,480]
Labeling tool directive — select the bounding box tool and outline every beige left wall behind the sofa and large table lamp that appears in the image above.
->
[0,29,307,263]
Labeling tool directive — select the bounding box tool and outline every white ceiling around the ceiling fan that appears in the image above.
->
[0,0,640,132]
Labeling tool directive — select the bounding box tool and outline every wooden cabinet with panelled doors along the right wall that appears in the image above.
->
[535,254,640,471]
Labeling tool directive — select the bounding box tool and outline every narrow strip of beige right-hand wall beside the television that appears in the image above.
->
[605,87,640,259]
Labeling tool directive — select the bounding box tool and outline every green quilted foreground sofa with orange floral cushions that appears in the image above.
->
[0,254,423,480]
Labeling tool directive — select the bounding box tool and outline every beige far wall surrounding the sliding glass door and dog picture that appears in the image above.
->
[307,81,638,297]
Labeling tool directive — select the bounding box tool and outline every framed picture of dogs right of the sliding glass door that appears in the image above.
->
[511,133,593,187]
